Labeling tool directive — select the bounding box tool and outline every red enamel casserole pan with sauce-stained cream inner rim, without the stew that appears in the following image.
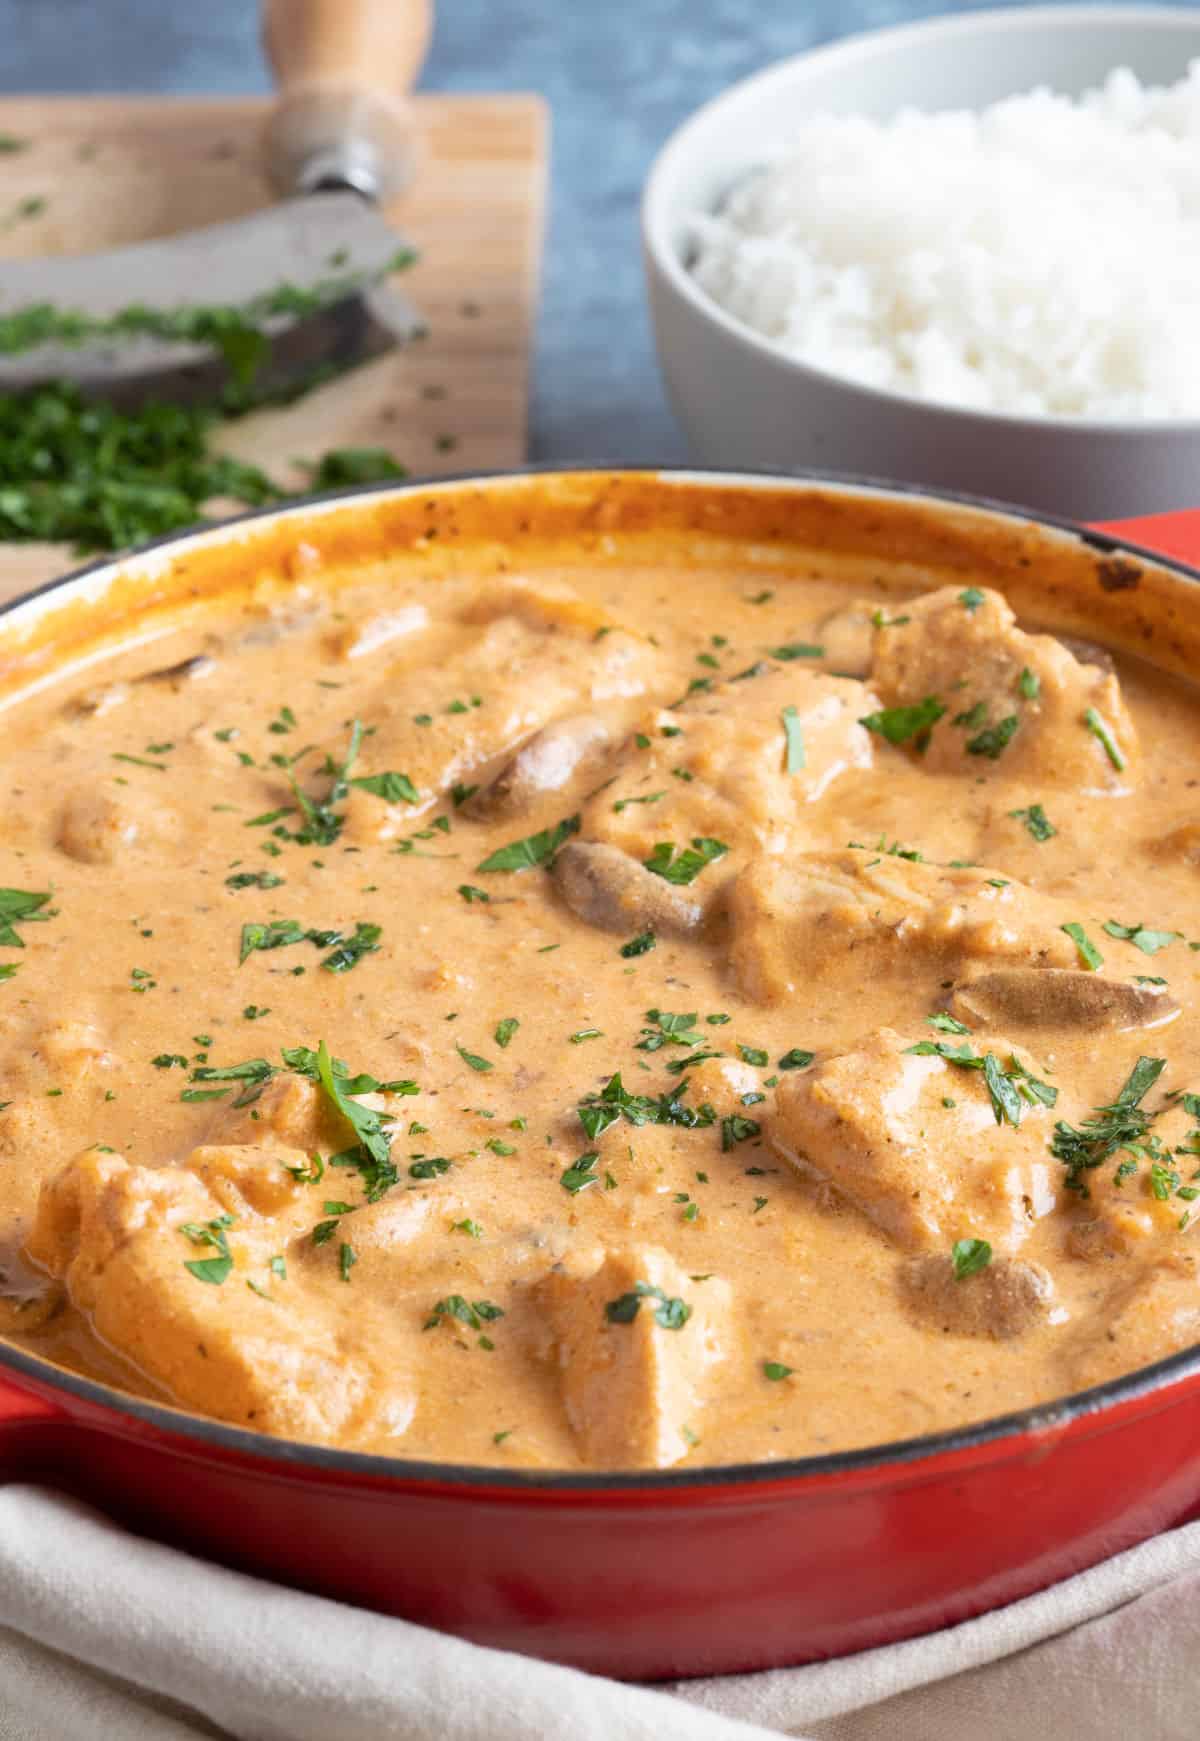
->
[0,472,1200,1680]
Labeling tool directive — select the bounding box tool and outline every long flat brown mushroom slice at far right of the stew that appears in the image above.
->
[949,968,1179,1034]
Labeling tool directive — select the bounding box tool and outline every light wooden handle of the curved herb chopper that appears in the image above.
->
[263,0,434,200]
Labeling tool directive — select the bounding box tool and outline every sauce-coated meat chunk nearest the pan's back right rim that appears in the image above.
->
[871,587,1137,794]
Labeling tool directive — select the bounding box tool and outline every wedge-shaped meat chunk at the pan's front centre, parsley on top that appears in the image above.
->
[536,1245,730,1469]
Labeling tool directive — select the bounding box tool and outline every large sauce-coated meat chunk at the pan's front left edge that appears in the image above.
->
[26,1149,413,1442]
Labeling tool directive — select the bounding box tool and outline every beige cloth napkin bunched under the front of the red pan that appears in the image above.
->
[0,1487,1200,1741]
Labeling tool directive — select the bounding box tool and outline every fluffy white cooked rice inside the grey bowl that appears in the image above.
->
[693,61,1200,418]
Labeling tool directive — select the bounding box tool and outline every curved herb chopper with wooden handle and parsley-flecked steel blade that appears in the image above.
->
[0,0,432,404]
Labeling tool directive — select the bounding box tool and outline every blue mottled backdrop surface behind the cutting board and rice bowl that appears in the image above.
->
[0,0,1191,460]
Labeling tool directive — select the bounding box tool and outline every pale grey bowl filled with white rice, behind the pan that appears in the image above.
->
[643,7,1200,519]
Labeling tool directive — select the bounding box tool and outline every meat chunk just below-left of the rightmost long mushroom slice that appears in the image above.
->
[766,1027,1057,1254]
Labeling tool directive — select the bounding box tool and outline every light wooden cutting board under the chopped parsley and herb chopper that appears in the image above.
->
[0,96,547,599]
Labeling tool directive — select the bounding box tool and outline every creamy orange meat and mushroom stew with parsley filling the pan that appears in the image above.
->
[0,490,1200,1468]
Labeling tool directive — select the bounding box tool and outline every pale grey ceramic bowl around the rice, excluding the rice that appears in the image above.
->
[643,5,1200,519]
